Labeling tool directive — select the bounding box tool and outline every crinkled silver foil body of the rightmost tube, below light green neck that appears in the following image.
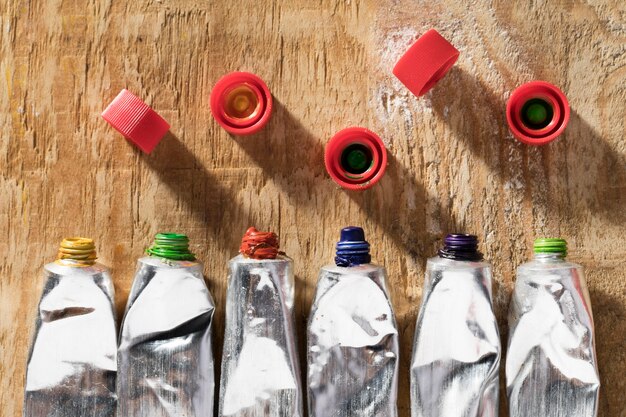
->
[506,259,600,417]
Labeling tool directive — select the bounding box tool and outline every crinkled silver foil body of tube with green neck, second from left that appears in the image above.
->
[117,257,215,417]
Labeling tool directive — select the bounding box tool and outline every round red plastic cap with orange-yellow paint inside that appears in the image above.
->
[210,72,272,136]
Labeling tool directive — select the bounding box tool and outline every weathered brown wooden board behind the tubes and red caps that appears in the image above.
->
[0,0,626,417]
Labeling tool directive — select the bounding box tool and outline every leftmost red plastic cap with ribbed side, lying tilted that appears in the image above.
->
[102,89,170,153]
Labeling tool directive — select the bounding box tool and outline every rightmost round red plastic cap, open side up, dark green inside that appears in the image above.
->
[506,81,570,145]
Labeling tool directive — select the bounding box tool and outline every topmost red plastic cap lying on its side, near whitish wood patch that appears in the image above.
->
[393,29,459,96]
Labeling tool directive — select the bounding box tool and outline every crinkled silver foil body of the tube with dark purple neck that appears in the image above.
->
[411,257,498,417]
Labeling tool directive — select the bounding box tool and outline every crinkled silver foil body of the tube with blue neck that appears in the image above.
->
[307,264,399,417]
